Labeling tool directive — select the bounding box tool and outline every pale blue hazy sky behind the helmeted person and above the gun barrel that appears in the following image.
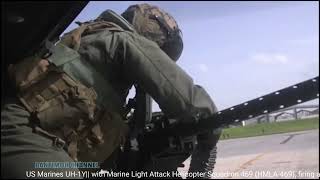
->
[66,1,319,110]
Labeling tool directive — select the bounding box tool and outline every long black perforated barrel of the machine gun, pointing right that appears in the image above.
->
[157,76,319,136]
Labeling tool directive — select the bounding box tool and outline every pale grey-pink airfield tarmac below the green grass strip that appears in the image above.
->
[178,129,319,179]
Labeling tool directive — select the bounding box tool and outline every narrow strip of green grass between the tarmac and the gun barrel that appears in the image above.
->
[220,117,319,140]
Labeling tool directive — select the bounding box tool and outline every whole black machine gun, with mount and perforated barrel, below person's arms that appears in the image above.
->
[119,76,319,170]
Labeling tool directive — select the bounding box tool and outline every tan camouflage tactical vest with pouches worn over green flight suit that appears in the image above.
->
[10,11,134,162]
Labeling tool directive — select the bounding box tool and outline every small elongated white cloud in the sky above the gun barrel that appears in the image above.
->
[251,53,289,65]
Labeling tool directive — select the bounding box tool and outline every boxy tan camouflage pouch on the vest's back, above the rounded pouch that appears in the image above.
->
[13,64,97,160]
